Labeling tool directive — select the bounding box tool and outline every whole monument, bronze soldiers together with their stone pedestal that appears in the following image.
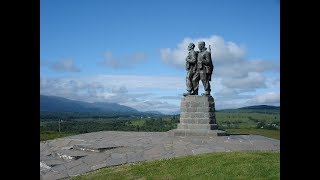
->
[173,41,226,136]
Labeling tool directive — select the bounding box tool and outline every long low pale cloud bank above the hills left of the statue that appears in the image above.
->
[40,75,185,113]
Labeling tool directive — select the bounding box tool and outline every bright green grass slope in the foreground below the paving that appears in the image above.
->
[71,151,280,180]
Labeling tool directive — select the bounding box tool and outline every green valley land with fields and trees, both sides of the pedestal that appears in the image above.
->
[40,110,280,140]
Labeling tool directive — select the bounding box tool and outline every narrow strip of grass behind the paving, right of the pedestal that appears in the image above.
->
[226,129,280,140]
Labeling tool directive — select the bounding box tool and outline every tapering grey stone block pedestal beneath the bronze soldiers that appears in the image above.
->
[173,95,226,136]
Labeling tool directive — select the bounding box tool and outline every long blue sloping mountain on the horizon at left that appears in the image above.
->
[40,95,140,113]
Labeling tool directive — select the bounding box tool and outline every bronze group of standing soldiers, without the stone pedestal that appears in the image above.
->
[183,41,213,96]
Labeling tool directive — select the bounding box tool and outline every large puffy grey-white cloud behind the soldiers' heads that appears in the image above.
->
[160,35,280,78]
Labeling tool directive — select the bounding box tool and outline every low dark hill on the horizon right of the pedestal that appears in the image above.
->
[218,105,280,114]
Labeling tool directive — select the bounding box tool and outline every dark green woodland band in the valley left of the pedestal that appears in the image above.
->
[40,113,179,136]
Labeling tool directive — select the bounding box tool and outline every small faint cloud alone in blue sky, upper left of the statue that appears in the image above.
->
[101,51,147,69]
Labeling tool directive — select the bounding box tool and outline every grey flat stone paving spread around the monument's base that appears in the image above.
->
[40,131,280,180]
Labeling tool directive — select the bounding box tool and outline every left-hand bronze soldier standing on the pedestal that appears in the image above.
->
[183,43,199,96]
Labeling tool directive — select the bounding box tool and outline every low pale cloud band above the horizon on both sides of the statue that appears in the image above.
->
[40,75,279,113]
